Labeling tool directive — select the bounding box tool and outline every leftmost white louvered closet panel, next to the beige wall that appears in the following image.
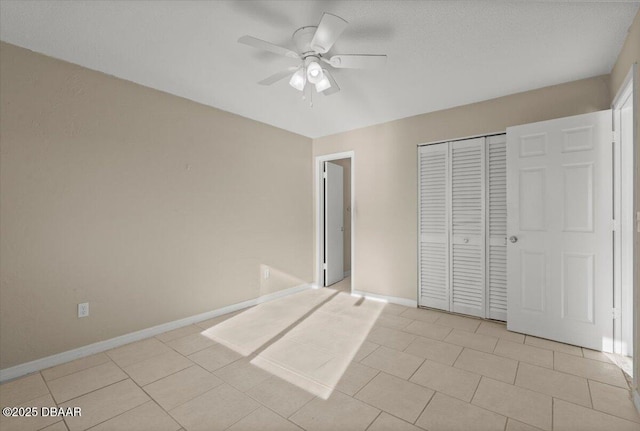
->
[418,143,450,310]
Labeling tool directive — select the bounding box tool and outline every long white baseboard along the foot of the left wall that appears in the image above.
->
[0,284,314,382]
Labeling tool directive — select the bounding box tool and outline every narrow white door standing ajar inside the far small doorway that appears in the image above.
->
[324,162,344,286]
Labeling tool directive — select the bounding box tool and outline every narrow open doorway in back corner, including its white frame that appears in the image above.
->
[316,151,354,293]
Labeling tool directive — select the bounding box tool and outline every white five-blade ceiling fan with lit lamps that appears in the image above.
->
[238,12,387,96]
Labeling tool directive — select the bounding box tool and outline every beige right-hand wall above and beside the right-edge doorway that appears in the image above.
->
[610,11,640,394]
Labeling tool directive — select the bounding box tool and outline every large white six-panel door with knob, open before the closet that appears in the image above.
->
[507,111,613,351]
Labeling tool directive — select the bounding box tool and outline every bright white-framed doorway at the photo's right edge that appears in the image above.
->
[612,64,637,384]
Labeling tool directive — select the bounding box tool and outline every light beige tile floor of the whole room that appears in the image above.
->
[0,280,640,431]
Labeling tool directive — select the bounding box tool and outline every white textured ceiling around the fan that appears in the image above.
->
[0,0,639,138]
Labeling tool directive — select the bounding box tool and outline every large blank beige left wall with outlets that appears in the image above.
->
[0,43,313,368]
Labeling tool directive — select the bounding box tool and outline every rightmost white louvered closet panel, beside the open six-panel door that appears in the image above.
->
[485,135,507,320]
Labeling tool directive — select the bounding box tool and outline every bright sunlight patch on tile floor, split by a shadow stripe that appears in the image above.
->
[201,280,386,399]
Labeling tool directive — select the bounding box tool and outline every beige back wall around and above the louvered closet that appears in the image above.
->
[313,75,610,300]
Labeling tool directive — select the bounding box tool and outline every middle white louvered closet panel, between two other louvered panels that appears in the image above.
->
[449,138,486,317]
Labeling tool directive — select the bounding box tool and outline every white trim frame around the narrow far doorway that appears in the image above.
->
[313,150,356,294]
